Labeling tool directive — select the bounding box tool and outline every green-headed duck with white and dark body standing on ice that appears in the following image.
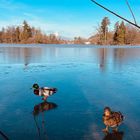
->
[32,83,57,101]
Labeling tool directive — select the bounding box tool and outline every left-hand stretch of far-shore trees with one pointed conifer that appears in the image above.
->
[0,21,65,44]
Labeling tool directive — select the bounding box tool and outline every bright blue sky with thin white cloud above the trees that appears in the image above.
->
[0,0,140,37]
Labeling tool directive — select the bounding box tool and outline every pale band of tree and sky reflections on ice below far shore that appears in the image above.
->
[0,46,140,72]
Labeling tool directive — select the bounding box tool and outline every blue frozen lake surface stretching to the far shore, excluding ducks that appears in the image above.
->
[0,45,140,140]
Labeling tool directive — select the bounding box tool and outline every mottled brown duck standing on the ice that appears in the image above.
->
[103,107,124,132]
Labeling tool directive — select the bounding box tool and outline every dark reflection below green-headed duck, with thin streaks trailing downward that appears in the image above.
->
[33,101,57,140]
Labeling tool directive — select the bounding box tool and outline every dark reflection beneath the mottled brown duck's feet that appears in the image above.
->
[103,131,124,140]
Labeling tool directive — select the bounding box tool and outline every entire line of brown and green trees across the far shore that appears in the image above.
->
[0,17,140,45]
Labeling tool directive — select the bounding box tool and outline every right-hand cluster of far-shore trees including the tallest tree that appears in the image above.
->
[88,17,140,45]
